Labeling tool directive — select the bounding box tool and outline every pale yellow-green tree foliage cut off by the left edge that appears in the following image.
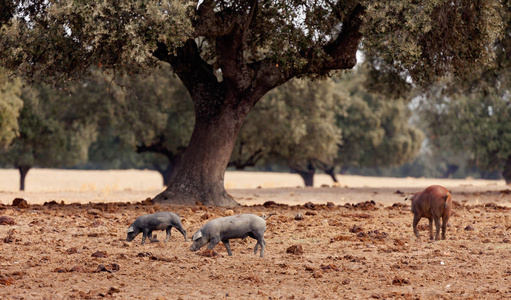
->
[0,68,23,148]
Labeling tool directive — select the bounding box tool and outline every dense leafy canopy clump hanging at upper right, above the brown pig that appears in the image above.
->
[363,0,509,96]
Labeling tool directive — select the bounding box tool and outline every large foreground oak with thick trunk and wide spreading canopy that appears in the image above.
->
[0,0,501,206]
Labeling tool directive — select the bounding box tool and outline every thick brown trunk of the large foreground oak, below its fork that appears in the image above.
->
[153,105,248,207]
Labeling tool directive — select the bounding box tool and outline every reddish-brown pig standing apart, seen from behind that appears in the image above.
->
[405,185,452,240]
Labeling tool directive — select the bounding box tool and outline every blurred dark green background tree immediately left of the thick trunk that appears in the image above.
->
[56,64,193,185]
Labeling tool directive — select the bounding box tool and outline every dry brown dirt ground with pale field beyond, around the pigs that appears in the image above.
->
[0,170,511,299]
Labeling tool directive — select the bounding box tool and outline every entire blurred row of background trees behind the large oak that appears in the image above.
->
[0,59,511,190]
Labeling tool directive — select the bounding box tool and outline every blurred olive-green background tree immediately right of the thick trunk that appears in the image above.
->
[234,79,341,186]
